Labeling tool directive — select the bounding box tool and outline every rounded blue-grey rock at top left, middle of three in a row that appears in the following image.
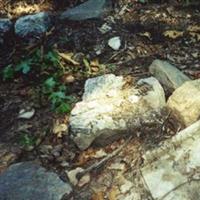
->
[15,12,52,39]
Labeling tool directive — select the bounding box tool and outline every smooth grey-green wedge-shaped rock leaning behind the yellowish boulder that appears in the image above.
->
[149,59,190,92]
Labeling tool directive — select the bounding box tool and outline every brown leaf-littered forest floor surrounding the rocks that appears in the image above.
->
[0,0,200,200]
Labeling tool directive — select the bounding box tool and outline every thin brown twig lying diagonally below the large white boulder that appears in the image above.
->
[77,136,132,180]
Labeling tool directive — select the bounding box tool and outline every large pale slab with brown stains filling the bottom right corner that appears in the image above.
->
[142,121,200,200]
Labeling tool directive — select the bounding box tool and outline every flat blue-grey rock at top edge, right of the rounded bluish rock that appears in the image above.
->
[60,0,110,21]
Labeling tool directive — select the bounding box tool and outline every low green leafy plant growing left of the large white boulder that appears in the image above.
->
[2,49,73,114]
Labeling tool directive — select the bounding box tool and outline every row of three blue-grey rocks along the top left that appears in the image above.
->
[0,0,111,45]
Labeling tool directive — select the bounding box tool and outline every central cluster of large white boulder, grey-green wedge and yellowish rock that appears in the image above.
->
[70,60,200,150]
